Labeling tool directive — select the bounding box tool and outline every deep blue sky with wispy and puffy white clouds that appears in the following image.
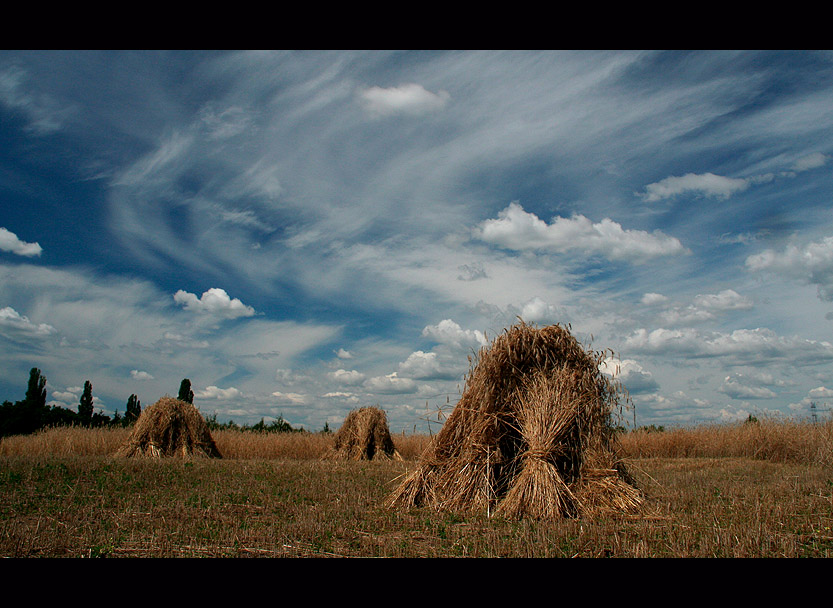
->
[0,50,833,433]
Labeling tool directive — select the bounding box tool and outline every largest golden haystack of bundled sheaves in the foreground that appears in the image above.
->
[386,321,642,518]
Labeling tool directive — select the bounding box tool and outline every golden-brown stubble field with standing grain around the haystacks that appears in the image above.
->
[0,421,833,558]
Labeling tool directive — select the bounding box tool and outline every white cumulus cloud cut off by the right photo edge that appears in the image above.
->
[746,237,833,301]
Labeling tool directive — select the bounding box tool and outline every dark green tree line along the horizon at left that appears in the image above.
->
[0,367,306,437]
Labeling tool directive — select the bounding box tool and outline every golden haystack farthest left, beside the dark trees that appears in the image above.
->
[116,396,222,458]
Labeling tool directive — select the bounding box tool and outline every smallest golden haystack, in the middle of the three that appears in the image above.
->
[331,407,402,460]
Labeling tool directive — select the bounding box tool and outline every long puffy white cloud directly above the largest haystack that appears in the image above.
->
[475,202,687,262]
